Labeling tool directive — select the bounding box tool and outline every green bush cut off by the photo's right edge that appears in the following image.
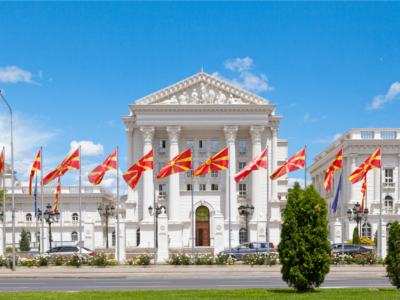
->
[386,221,400,289]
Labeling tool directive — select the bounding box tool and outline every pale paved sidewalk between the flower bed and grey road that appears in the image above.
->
[0,265,386,279]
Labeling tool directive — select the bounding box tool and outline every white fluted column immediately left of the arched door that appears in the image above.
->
[167,126,181,220]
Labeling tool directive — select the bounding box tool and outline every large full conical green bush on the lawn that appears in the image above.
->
[278,182,330,291]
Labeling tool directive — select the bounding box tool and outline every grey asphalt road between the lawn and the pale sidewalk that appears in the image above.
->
[0,277,393,292]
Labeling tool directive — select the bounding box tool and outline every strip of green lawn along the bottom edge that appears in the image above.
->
[0,288,400,300]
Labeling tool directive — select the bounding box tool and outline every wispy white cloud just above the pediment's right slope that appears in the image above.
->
[212,71,274,93]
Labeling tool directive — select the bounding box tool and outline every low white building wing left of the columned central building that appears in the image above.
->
[0,164,118,254]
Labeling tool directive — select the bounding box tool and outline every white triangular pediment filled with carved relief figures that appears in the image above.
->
[136,72,268,105]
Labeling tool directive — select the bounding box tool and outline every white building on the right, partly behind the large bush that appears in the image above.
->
[307,128,400,256]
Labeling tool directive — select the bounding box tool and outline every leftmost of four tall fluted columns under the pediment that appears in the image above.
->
[140,126,156,221]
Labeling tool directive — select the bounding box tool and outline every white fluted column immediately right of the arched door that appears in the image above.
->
[224,126,239,221]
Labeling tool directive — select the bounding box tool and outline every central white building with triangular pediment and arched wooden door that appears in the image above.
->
[122,73,288,250]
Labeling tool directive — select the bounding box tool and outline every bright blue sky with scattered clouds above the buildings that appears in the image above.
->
[0,2,400,195]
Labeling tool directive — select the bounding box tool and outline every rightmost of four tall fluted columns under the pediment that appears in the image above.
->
[250,126,266,220]
